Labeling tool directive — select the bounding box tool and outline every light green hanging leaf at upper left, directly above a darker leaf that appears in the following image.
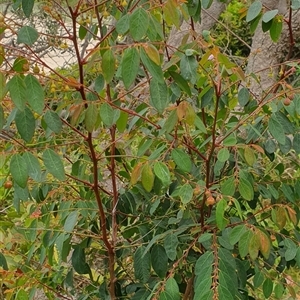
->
[24,74,45,114]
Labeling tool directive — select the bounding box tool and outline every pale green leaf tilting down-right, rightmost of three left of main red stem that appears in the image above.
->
[43,149,66,181]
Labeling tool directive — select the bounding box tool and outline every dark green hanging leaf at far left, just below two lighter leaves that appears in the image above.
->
[15,107,35,143]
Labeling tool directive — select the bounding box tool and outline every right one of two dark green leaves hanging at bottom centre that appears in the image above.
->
[151,244,168,278]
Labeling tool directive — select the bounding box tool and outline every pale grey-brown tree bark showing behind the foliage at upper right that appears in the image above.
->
[168,0,300,97]
